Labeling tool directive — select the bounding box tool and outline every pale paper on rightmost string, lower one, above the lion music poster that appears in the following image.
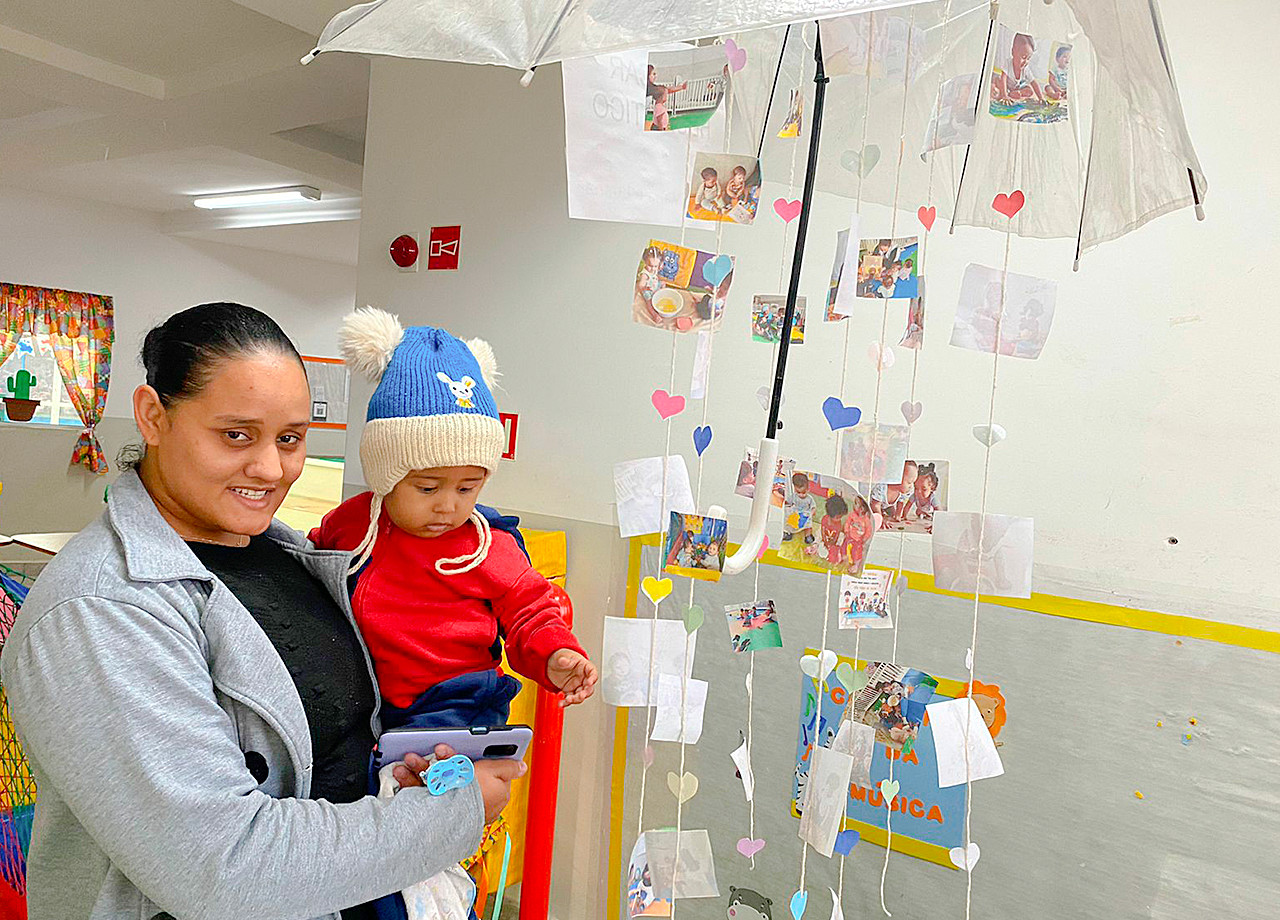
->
[933,511,1036,598]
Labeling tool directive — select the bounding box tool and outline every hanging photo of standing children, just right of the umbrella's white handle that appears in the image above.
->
[778,471,876,575]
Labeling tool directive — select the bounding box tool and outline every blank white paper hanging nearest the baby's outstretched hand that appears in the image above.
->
[600,617,698,706]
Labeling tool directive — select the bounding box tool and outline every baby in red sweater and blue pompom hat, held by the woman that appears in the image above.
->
[310,307,596,728]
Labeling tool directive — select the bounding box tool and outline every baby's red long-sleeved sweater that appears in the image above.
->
[310,493,585,708]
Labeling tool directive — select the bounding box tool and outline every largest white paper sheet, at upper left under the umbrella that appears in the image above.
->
[561,51,724,226]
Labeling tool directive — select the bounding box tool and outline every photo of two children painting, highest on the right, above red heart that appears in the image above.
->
[991,26,1071,124]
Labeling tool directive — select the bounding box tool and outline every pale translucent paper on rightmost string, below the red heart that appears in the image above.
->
[951,265,1057,358]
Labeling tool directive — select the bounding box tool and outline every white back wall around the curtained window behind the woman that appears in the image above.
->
[0,187,356,532]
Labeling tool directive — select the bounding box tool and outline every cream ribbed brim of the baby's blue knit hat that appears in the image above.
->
[360,413,507,495]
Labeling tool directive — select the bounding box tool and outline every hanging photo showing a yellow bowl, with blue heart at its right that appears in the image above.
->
[631,239,733,333]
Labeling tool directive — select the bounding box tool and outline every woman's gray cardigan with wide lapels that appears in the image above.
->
[0,472,484,920]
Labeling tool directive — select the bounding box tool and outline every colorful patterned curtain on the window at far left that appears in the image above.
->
[0,282,115,476]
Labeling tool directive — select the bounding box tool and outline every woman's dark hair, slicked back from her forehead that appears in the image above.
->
[116,302,302,470]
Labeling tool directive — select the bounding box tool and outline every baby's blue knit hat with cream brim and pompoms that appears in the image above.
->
[339,307,506,573]
